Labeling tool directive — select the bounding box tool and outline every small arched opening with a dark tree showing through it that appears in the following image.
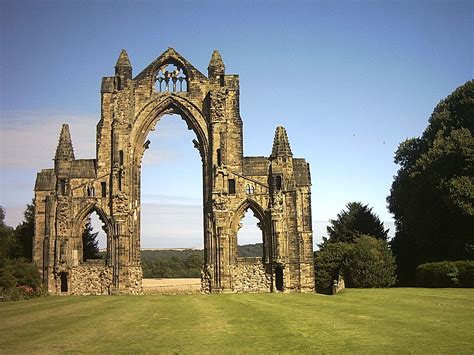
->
[82,211,107,261]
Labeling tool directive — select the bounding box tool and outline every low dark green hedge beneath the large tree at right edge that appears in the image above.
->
[416,260,474,287]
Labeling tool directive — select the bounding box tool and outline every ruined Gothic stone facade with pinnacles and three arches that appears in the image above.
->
[33,48,314,294]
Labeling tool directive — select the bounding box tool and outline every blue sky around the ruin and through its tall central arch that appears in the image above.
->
[0,0,474,247]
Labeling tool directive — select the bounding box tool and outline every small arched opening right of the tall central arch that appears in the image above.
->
[237,209,263,258]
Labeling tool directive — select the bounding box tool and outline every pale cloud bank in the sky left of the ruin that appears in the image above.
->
[0,110,99,226]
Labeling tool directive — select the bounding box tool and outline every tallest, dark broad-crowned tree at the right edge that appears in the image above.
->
[387,80,474,284]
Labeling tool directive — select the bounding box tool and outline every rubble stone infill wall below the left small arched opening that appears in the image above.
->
[69,260,112,295]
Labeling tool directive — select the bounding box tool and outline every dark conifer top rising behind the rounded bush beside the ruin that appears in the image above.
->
[327,202,388,243]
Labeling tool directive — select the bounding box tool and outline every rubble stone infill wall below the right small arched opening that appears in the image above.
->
[231,258,271,292]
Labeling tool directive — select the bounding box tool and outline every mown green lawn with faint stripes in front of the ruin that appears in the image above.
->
[0,288,474,354]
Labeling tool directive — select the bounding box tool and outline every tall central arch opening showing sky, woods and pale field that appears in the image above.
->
[140,114,204,280]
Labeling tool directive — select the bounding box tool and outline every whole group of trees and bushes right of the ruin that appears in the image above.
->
[315,80,474,292]
